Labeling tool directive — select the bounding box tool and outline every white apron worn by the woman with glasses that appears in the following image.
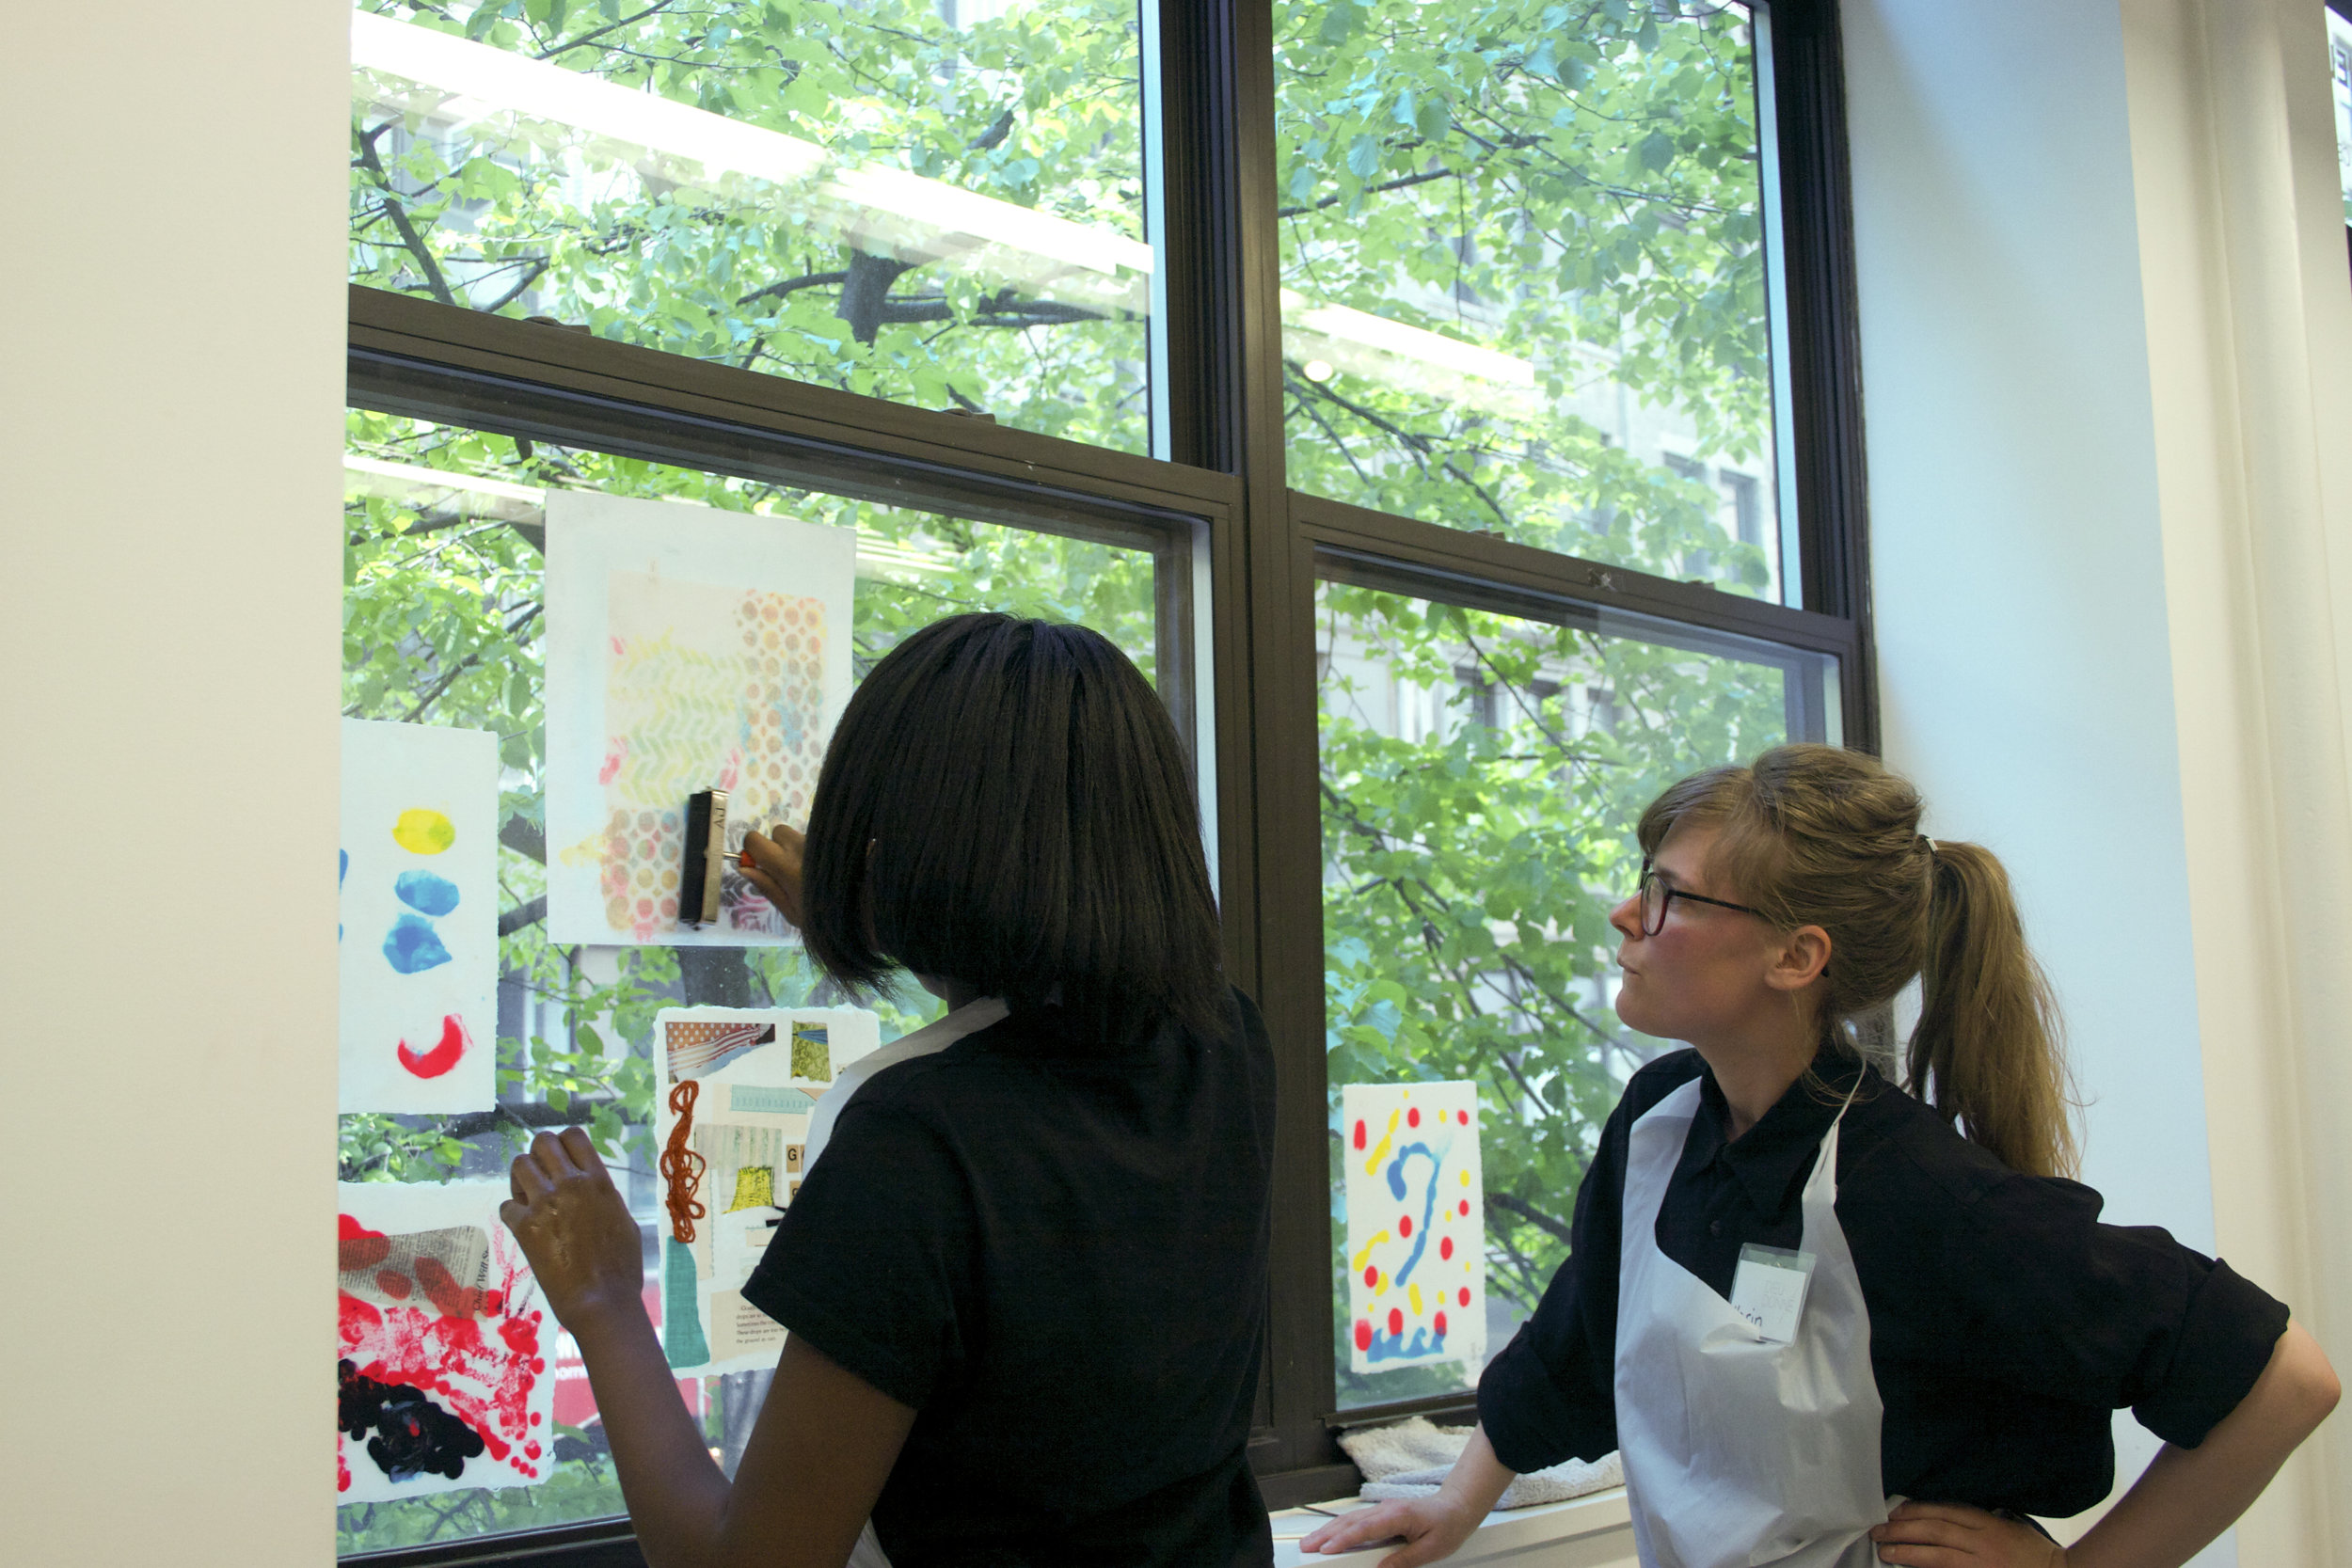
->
[1616,1079,1886,1568]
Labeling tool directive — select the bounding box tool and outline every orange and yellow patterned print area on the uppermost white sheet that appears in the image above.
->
[597,571,828,942]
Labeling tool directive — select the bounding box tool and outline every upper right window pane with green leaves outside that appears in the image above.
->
[1275,0,1792,599]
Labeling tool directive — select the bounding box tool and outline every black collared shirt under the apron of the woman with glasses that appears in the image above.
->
[1477,1051,2286,1519]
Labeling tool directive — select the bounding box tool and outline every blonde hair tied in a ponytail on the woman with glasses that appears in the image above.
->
[1640,745,2074,1176]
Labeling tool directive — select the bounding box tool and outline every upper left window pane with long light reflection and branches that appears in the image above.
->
[351,0,1152,451]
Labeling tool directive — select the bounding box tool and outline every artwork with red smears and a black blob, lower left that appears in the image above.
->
[334,1180,555,1502]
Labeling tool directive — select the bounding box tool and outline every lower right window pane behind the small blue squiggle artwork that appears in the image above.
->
[1317,573,1837,1408]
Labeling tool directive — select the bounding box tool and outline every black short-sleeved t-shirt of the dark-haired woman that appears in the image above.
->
[743,992,1275,1568]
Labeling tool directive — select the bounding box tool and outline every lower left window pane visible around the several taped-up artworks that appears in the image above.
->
[337,411,1179,1554]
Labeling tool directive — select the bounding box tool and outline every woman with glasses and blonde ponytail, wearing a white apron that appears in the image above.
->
[1301,745,2338,1568]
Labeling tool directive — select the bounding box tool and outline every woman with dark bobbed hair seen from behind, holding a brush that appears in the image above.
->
[506,616,1273,1568]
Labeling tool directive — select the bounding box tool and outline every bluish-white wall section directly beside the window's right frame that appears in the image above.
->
[1844,0,2201,1563]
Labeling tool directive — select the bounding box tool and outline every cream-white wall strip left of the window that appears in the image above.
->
[0,0,348,1568]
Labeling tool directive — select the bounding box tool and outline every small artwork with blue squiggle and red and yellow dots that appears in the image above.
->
[1341,1084,1486,1373]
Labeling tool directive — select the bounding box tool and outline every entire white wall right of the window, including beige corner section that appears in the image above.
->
[1844,0,2352,1566]
